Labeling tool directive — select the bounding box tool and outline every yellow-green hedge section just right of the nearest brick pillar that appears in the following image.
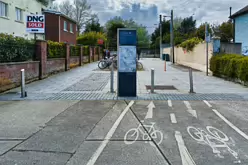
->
[47,41,66,58]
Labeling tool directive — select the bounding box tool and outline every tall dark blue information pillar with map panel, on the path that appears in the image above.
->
[117,28,137,97]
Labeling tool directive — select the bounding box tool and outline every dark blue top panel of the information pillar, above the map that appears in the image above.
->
[119,30,137,45]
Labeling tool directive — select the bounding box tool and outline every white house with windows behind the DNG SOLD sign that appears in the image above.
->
[0,0,54,39]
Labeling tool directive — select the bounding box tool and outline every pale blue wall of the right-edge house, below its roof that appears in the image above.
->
[235,14,248,55]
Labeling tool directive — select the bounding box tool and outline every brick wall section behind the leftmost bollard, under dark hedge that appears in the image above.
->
[0,61,39,92]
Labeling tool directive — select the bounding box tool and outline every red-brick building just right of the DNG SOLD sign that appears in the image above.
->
[43,10,77,44]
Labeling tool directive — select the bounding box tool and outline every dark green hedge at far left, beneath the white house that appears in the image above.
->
[0,33,35,62]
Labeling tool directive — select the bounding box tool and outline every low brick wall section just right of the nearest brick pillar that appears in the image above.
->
[46,58,65,75]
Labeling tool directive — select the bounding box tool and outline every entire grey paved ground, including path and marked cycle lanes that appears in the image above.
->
[0,59,248,165]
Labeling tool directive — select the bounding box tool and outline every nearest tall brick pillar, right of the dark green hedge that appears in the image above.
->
[35,40,48,80]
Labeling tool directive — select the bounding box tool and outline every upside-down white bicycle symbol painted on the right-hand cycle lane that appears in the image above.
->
[187,126,238,159]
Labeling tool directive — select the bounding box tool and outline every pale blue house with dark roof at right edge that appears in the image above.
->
[230,5,248,55]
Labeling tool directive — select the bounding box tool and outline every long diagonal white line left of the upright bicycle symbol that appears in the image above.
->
[87,101,134,165]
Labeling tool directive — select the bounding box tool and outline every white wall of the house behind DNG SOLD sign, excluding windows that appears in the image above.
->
[0,0,52,39]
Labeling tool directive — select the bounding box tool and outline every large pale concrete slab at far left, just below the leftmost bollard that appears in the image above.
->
[0,101,77,139]
